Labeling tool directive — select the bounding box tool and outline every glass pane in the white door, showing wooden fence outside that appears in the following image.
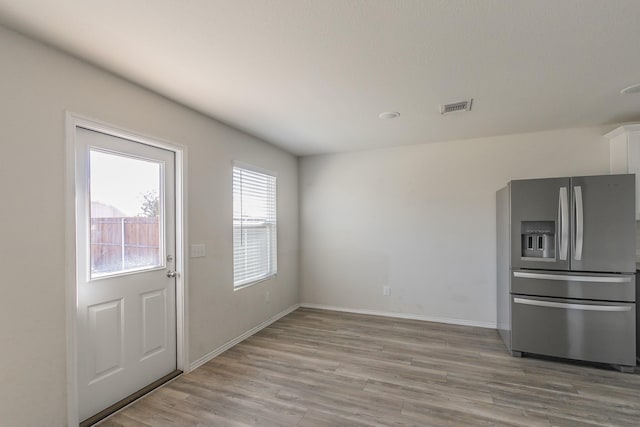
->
[89,149,164,279]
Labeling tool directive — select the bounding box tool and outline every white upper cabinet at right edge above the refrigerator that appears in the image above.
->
[605,124,640,220]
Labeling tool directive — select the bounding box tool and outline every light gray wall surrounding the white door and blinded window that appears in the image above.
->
[0,27,299,426]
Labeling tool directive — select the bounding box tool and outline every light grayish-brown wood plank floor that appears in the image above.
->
[102,309,640,427]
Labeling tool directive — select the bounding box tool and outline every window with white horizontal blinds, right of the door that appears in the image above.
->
[233,165,278,288]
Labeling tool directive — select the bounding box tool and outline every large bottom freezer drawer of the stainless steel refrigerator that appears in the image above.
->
[511,295,636,366]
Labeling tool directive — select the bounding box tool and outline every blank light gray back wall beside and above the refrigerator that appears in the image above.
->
[300,128,610,327]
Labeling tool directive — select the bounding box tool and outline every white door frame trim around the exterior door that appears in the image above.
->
[65,111,189,426]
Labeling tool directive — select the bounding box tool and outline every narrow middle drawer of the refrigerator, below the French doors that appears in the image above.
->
[511,271,636,302]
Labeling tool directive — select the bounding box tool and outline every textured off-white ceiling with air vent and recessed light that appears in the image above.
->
[0,0,640,155]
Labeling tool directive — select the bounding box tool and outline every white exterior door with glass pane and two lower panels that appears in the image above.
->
[76,127,176,420]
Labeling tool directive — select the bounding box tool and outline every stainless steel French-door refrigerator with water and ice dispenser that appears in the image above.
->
[496,175,636,371]
